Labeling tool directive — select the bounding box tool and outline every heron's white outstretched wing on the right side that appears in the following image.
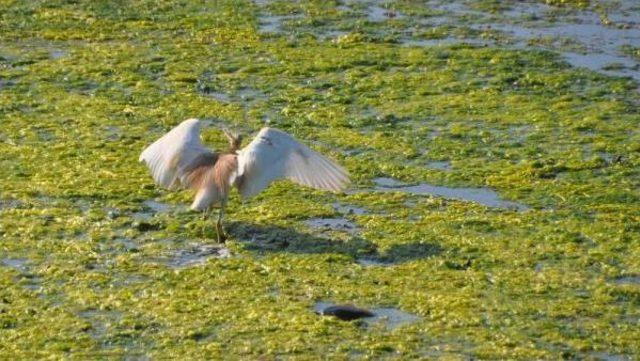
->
[237,128,349,197]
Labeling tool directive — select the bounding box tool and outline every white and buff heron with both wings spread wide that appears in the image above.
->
[139,119,349,242]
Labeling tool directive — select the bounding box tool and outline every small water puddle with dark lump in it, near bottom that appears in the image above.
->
[313,302,420,331]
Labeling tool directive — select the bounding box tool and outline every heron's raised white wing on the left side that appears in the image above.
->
[139,119,217,189]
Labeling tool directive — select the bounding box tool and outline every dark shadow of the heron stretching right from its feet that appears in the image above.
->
[227,222,443,264]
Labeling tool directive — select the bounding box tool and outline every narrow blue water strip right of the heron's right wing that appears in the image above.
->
[373,178,529,211]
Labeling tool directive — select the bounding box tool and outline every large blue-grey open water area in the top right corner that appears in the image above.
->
[398,0,640,81]
